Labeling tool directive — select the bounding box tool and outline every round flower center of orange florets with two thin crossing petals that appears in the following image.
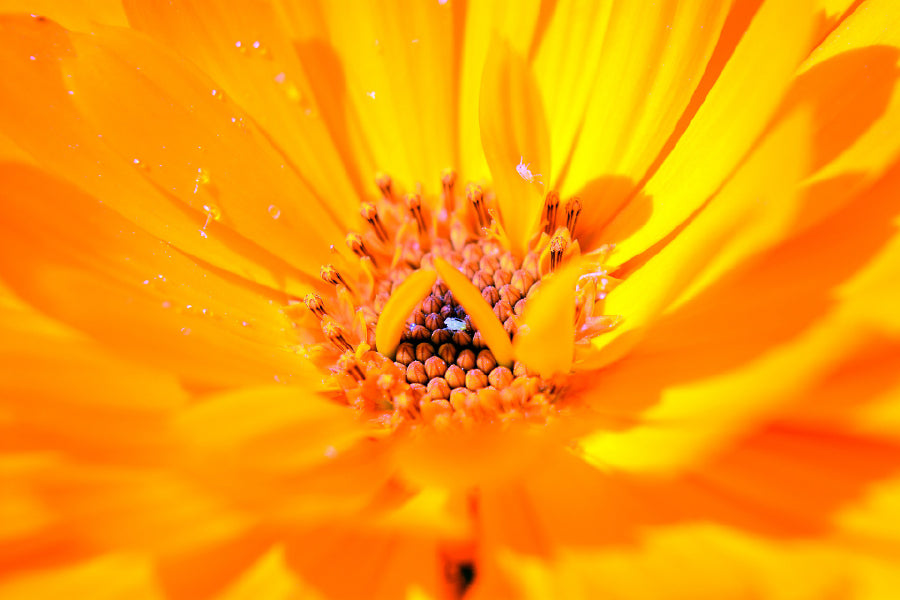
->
[305,171,596,428]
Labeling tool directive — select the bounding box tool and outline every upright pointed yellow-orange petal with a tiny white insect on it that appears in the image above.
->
[479,41,551,256]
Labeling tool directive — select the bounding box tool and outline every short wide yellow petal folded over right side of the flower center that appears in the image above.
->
[513,261,580,377]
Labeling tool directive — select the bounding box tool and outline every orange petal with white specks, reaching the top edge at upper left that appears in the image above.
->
[125,0,371,212]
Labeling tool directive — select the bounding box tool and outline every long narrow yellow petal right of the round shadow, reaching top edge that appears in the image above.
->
[604,0,812,261]
